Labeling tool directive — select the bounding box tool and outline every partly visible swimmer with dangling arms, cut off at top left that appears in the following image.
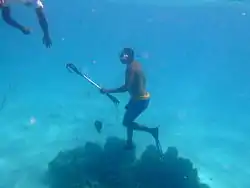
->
[0,0,52,48]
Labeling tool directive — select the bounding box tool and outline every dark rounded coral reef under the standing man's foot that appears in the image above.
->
[47,137,208,188]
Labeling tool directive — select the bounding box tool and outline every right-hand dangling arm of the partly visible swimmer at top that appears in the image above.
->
[36,7,52,47]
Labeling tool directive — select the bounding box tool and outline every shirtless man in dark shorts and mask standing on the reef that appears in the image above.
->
[101,48,159,150]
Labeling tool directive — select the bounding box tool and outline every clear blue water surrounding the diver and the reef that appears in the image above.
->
[0,0,250,188]
